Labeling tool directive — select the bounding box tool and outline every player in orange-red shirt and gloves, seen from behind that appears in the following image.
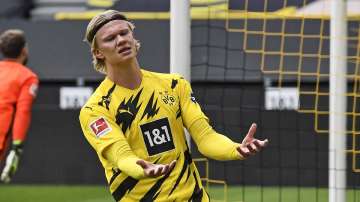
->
[0,29,39,182]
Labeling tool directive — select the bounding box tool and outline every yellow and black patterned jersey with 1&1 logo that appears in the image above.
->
[80,70,209,201]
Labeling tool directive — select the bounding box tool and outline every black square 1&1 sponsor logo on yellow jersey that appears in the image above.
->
[140,118,175,156]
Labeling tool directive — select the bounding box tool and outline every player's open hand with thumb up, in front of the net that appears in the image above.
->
[236,123,269,158]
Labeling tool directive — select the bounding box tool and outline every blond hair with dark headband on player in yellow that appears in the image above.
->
[84,10,140,74]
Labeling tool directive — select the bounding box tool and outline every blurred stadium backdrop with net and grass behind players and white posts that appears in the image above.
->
[0,0,360,202]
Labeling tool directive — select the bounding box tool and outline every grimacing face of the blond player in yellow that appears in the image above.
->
[94,20,137,64]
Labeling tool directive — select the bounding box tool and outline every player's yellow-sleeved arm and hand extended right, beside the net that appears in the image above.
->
[179,76,268,160]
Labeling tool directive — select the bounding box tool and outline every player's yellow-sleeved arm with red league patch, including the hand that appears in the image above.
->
[79,107,175,179]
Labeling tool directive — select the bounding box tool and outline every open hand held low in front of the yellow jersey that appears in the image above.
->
[136,160,176,177]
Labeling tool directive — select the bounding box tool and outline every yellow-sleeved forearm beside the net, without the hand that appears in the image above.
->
[189,119,242,160]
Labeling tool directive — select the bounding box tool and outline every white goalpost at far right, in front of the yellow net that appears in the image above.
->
[329,0,347,202]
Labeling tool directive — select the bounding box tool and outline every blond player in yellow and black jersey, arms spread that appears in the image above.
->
[79,10,268,201]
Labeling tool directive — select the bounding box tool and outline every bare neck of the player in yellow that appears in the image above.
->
[107,59,142,90]
